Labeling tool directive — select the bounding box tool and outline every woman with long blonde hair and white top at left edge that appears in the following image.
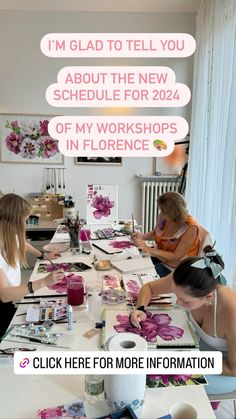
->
[0,194,64,339]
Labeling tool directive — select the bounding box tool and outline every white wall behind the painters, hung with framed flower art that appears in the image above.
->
[0,11,195,221]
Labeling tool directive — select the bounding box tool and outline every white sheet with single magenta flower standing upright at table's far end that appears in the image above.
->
[86,184,118,224]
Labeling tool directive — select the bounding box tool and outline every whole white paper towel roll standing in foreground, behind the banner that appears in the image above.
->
[104,333,147,410]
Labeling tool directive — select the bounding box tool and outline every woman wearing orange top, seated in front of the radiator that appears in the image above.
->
[132,192,201,277]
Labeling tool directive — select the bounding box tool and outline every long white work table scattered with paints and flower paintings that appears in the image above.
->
[0,231,215,419]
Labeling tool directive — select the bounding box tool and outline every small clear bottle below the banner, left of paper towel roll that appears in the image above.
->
[84,375,104,403]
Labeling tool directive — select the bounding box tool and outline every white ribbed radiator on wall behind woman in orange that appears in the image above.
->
[142,176,180,233]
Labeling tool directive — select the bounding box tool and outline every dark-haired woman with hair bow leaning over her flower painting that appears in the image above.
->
[130,246,236,394]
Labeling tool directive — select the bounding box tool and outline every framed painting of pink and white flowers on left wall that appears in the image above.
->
[0,114,64,165]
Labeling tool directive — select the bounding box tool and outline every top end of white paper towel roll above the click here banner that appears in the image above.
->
[105,333,147,351]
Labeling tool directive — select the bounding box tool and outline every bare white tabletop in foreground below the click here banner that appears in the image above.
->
[0,365,215,419]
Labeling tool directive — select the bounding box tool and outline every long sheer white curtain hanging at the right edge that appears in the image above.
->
[186,0,236,287]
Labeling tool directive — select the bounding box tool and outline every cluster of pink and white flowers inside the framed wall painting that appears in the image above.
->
[5,120,59,160]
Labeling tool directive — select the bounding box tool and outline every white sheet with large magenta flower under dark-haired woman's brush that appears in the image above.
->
[102,307,198,349]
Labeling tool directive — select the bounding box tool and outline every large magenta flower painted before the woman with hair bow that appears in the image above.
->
[113,311,184,342]
